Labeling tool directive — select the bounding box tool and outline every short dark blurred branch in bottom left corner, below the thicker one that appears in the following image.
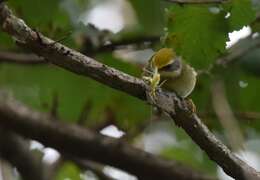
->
[0,127,44,180]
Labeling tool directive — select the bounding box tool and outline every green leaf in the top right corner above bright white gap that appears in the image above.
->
[224,0,255,31]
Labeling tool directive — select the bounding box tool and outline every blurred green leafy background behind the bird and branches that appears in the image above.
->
[0,0,260,180]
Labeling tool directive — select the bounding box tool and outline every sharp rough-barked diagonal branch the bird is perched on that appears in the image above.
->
[0,4,260,179]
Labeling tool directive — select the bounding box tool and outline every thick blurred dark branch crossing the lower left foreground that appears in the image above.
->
[0,93,208,179]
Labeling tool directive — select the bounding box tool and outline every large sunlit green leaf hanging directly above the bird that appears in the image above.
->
[166,5,228,68]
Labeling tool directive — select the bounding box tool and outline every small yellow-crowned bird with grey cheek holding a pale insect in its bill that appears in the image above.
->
[142,48,197,98]
